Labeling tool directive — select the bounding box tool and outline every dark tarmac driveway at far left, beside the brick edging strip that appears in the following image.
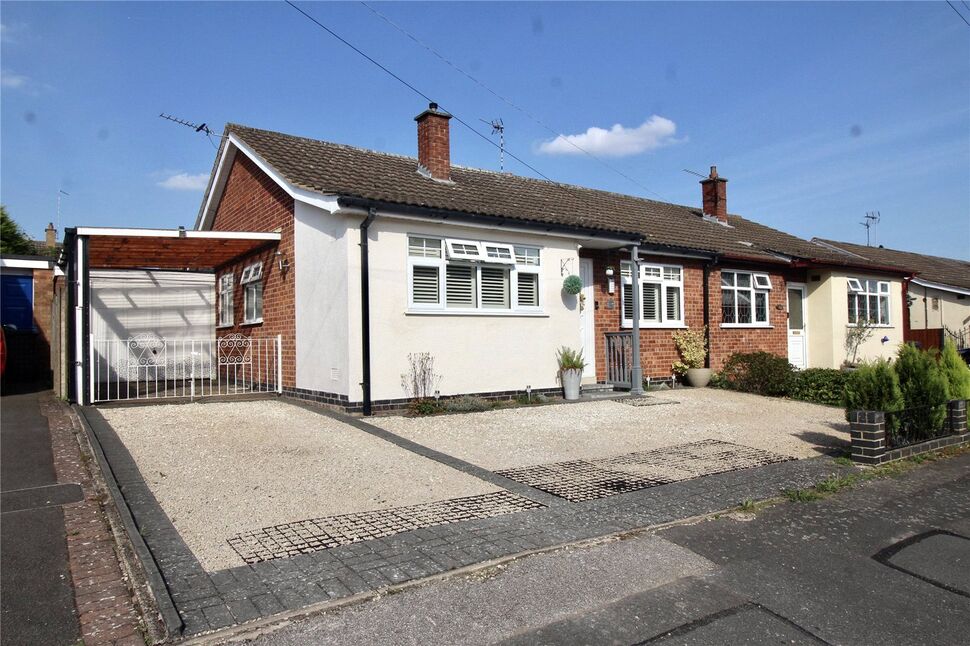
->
[0,392,81,646]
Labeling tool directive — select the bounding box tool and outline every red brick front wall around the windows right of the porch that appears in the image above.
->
[581,251,804,381]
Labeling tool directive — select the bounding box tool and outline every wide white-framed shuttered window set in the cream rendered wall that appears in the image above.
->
[408,235,542,314]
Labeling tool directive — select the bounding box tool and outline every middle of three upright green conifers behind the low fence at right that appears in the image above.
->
[894,343,950,439]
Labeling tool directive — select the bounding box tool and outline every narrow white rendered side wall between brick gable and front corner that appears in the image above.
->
[293,201,352,400]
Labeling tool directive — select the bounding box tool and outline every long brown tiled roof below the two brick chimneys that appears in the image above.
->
[216,124,888,264]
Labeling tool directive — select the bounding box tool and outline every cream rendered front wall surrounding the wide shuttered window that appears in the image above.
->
[347,217,581,401]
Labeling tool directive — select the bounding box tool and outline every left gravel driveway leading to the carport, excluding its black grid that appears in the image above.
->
[101,401,498,571]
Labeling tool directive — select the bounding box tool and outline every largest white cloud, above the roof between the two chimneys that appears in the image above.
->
[539,115,679,157]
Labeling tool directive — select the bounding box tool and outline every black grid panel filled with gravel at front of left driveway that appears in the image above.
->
[228,491,545,563]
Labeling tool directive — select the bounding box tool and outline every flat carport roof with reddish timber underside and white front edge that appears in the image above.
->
[71,227,280,271]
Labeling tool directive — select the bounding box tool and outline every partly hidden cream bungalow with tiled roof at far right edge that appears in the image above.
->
[813,238,970,348]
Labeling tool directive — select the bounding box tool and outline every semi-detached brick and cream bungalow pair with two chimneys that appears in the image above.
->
[185,104,911,414]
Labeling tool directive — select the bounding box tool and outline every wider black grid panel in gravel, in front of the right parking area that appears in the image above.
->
[497,440,794,502]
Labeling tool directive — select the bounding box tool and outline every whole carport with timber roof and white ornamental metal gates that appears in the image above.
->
[59,227,281,404]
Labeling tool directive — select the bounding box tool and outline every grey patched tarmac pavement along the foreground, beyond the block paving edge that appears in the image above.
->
[237,453,970,646]
